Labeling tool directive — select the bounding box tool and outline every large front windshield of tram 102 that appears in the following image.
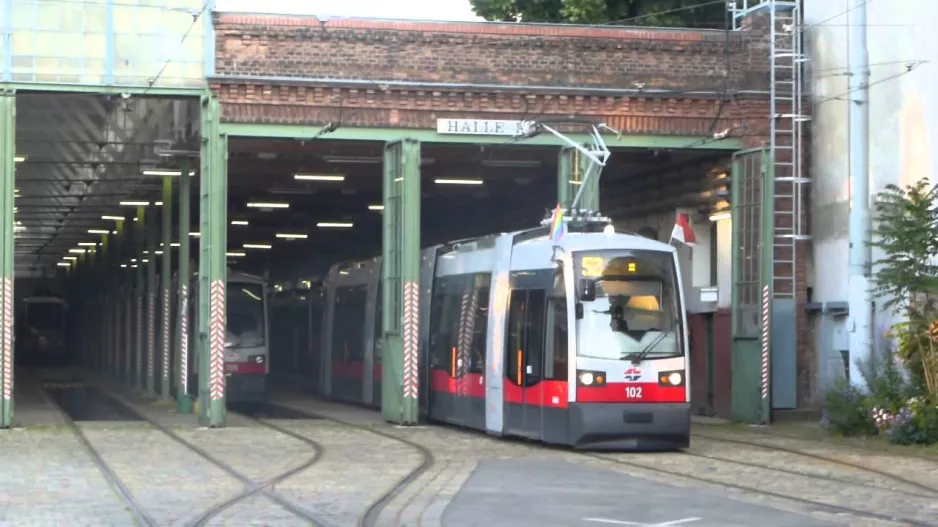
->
[575,250,681,360]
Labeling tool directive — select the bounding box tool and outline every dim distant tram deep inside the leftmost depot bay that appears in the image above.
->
[16,294,68,365]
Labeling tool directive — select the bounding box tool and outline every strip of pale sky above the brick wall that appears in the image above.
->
[215,0,481,21]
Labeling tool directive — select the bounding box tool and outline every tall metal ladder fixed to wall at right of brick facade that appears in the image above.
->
[765,0,810,299]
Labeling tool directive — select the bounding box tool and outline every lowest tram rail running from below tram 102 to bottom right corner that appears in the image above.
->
[579,452,938,527]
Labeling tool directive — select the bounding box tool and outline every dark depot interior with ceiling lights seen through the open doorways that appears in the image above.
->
[15,95,729,388]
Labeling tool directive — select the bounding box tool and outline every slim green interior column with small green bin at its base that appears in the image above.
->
[176,159,192,411]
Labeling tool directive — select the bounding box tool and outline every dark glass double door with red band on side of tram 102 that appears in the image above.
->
[505,289,547,438]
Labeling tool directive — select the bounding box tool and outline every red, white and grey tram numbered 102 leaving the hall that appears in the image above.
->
[321,217,690,450]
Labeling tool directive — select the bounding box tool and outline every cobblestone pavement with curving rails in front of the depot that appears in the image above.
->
[0,386,938,527]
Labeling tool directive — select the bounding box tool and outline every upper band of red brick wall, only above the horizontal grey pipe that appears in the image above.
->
[215,14,759,91]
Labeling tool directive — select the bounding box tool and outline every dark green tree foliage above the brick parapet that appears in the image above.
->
[470,0,727,29]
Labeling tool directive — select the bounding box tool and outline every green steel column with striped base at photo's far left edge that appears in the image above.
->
[0,91,16,428]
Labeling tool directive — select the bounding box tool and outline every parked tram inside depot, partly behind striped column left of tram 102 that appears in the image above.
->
[188,269,270,402]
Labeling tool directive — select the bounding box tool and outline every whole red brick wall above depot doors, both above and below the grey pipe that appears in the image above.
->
[212,14,768,136]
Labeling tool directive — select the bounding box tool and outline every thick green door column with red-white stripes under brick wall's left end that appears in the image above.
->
[198,95,228,427]
